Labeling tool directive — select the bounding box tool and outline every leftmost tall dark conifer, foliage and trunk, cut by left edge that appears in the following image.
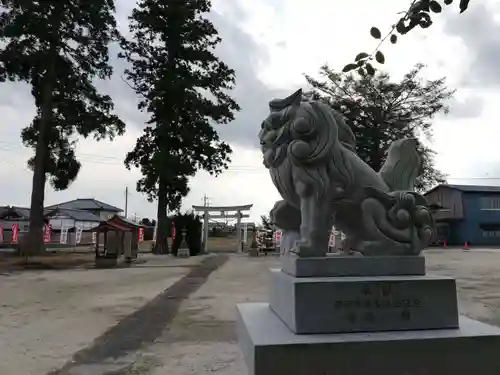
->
[0,0,125,252]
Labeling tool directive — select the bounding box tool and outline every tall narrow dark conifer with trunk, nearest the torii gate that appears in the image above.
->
[121,0,239,253]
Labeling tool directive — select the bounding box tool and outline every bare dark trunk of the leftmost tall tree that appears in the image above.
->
[21,60,55,256]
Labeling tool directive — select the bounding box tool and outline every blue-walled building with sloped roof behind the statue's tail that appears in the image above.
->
[425,184,500,246]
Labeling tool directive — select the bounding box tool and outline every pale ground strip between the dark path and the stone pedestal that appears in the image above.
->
[140,255,278,375]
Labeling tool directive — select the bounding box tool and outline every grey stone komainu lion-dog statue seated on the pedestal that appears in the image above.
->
[259,90,434,257]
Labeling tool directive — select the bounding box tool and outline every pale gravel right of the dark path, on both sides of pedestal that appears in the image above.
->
[141,250,500,375]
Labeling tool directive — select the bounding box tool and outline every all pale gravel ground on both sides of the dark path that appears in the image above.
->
[4,249,500,375]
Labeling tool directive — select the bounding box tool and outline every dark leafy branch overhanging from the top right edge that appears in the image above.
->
[342,0,470,75]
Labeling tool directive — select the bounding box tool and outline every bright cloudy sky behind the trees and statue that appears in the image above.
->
[0,0,500,220]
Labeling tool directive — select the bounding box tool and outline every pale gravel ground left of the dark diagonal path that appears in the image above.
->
[0,256,206,375]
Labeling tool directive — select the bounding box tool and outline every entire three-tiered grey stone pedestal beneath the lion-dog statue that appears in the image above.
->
[238,256,500,375]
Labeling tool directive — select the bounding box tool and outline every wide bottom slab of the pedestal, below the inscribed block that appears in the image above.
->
[237,303,500,375]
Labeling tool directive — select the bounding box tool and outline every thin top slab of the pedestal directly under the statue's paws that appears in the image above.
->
[281,254,425,277]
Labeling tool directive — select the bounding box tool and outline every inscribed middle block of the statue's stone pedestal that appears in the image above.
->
[269,269,458,334]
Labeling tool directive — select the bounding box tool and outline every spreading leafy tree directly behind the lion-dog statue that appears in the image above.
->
[306,64,454,191]
